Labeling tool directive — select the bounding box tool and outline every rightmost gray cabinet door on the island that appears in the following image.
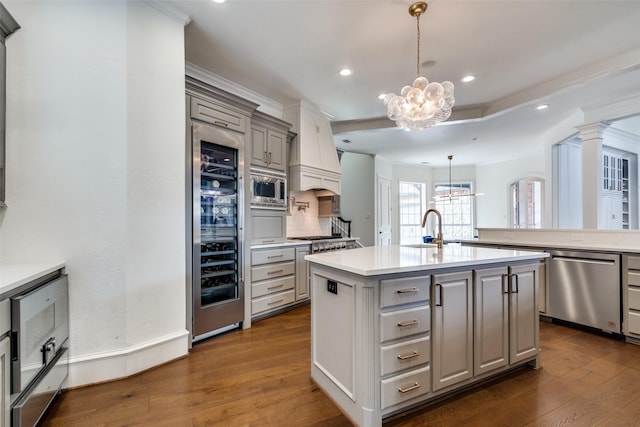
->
[509,265,539,363]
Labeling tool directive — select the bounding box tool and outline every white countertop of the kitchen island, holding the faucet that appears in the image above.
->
[305,243,549,276]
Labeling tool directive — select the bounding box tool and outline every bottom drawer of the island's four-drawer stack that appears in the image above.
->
[380,366,430,410]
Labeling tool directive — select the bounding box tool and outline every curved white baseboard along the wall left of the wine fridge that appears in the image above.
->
[68,330,189,387]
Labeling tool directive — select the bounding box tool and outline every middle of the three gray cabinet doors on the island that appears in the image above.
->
[474,267,509,375]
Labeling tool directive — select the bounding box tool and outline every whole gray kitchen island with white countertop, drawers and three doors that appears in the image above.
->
[305,244,548,427]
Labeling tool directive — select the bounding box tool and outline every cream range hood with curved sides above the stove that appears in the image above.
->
[283,100,342,194]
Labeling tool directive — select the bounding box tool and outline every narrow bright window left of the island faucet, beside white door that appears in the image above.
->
[398,181,426,245]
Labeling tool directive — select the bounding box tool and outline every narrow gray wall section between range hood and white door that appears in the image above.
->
[340,152,376,246]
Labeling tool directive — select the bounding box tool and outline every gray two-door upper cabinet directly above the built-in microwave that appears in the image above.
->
[251,111,291,172]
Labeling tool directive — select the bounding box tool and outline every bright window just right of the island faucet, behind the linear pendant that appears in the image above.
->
[431,182,474,240]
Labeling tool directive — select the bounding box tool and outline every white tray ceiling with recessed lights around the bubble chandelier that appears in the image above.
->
[166,0,640,166]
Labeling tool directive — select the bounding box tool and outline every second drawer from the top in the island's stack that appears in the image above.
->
[380,305,431,342]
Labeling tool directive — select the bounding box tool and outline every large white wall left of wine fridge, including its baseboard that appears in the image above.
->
[0,0,188,386]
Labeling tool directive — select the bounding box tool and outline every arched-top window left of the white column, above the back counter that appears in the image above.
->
[509,178,544,228]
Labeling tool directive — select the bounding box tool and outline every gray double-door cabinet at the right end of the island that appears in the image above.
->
[474,265,539,375]
